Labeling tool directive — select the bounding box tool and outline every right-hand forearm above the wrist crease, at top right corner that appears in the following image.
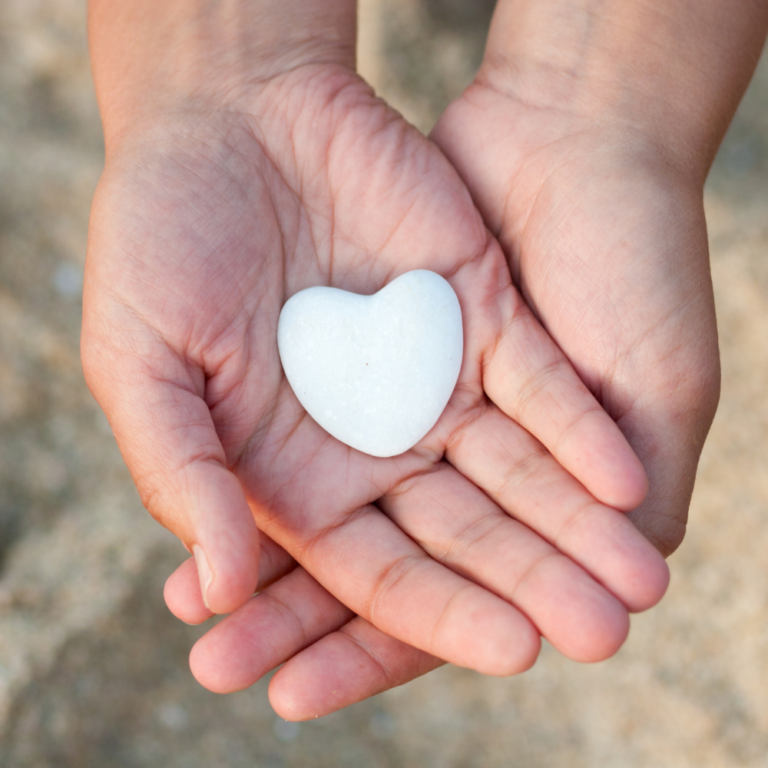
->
[480,0,768,181]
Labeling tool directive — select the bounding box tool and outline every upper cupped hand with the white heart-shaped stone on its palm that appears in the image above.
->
[83,65,667,706]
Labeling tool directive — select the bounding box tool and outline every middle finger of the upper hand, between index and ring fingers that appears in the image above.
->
[379,463,629,662]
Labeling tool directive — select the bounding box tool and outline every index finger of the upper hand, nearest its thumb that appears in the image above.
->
[256,506,540,675]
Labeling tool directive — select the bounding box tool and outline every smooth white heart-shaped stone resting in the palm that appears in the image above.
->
[277,269,464,457]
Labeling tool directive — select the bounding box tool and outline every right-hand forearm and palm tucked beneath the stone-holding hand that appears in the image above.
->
[426,0,768,555]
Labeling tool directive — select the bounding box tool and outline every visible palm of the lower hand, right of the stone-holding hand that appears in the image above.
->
[435,81,718,554]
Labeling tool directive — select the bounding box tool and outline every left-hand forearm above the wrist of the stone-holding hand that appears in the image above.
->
[88,0,356,149]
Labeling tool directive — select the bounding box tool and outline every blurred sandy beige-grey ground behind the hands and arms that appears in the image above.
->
[0,0,768,768]
